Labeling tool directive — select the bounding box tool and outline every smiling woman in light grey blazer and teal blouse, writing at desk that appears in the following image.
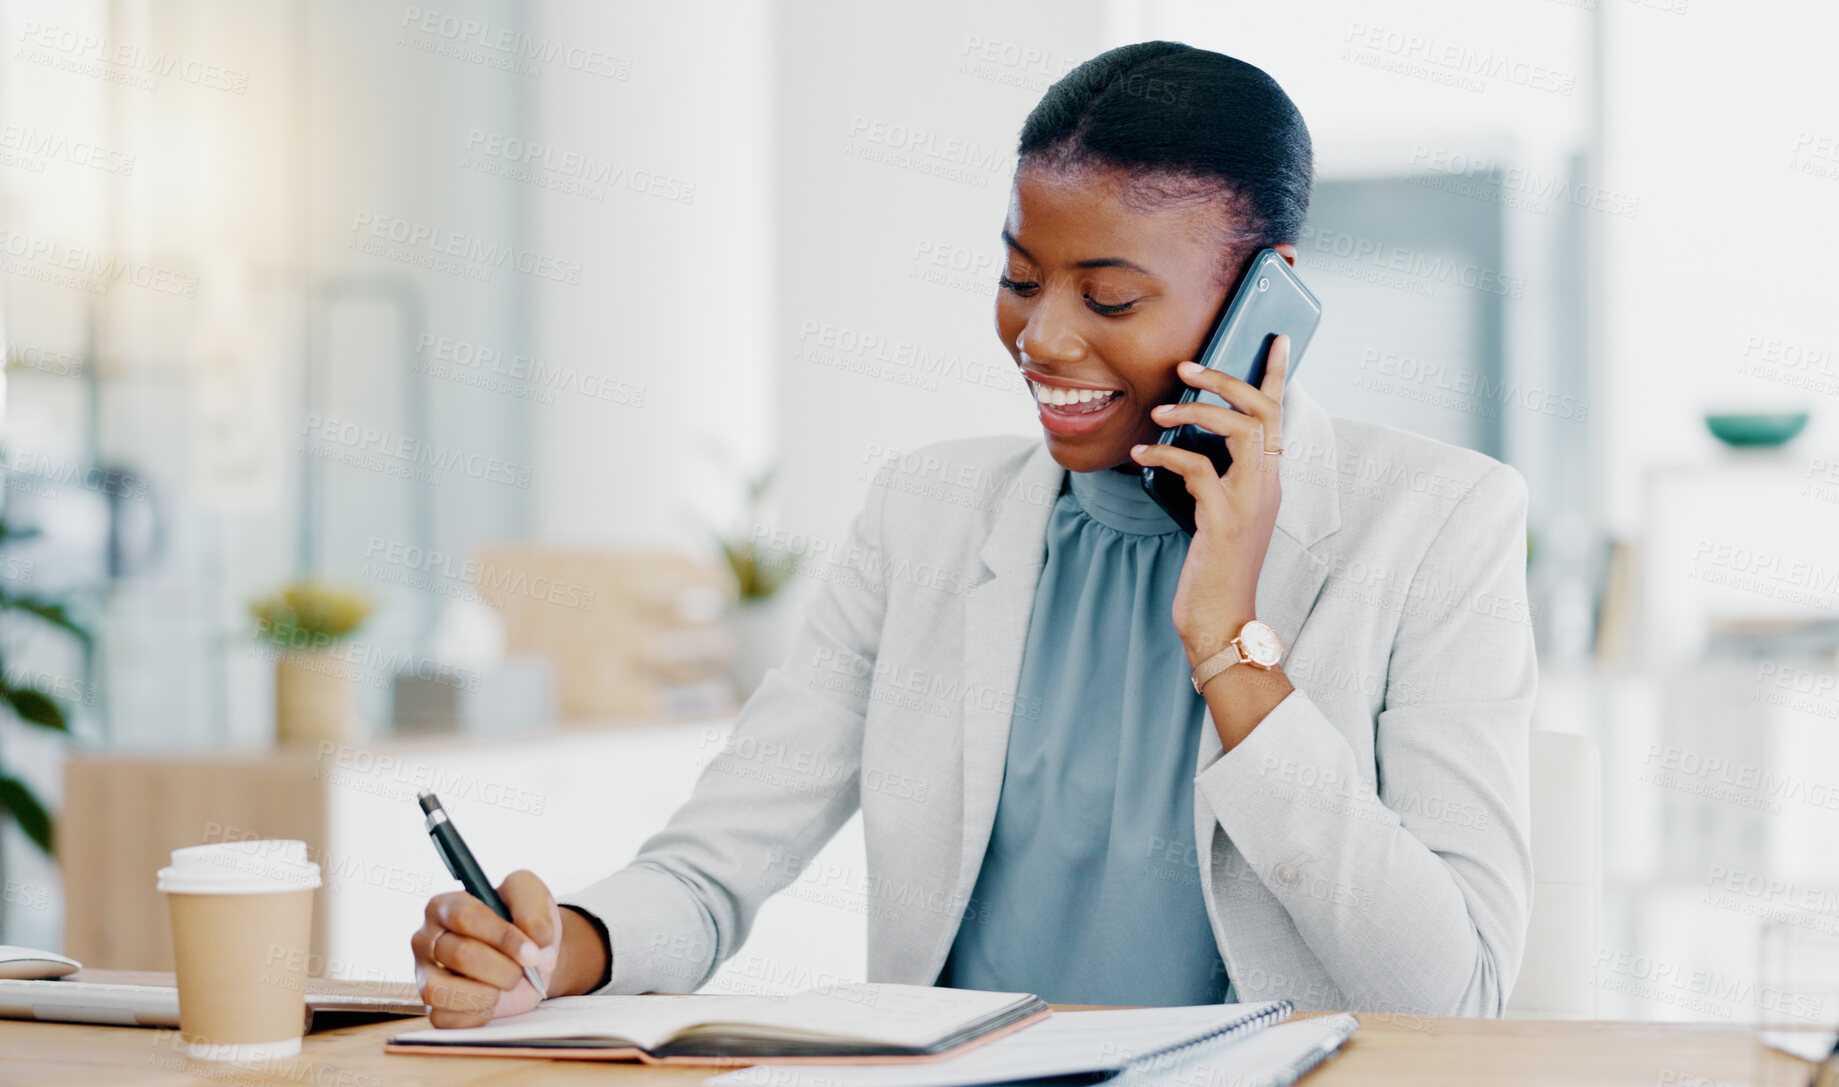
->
[412,42,1536,1026]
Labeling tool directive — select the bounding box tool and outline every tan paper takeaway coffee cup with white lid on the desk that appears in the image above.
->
[160,839,320,1061]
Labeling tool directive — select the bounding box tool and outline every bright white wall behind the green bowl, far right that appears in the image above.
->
[1602,0,1839,533]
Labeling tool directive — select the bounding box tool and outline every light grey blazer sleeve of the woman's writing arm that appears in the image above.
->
[559,467,886,993]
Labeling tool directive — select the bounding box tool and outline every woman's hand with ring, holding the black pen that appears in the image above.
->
[408,872,607,1026]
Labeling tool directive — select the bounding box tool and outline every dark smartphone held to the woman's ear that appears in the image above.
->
[1142,248,1322,535]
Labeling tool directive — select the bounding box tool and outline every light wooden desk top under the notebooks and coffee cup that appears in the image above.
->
[0,1015,1797,1087]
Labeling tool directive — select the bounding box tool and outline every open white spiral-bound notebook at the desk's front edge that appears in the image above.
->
[706,1001,1324,1087]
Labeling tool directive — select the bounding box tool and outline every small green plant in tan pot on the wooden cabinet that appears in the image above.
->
[248,579,371,743]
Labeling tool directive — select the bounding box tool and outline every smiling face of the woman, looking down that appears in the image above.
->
[997,167,1295,471]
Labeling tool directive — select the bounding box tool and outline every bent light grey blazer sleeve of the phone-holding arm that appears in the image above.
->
[1195,465,1537,1015]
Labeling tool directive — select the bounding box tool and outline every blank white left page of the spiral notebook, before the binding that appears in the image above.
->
[704,1004,1273,1087]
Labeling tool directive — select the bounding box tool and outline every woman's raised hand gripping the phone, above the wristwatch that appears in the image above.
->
[1131,337,1289,668]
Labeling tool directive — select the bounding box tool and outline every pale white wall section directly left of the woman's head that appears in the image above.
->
[772,0,1111,541]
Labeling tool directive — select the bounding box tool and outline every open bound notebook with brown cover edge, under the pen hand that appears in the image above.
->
[384,984,1048,1065]
